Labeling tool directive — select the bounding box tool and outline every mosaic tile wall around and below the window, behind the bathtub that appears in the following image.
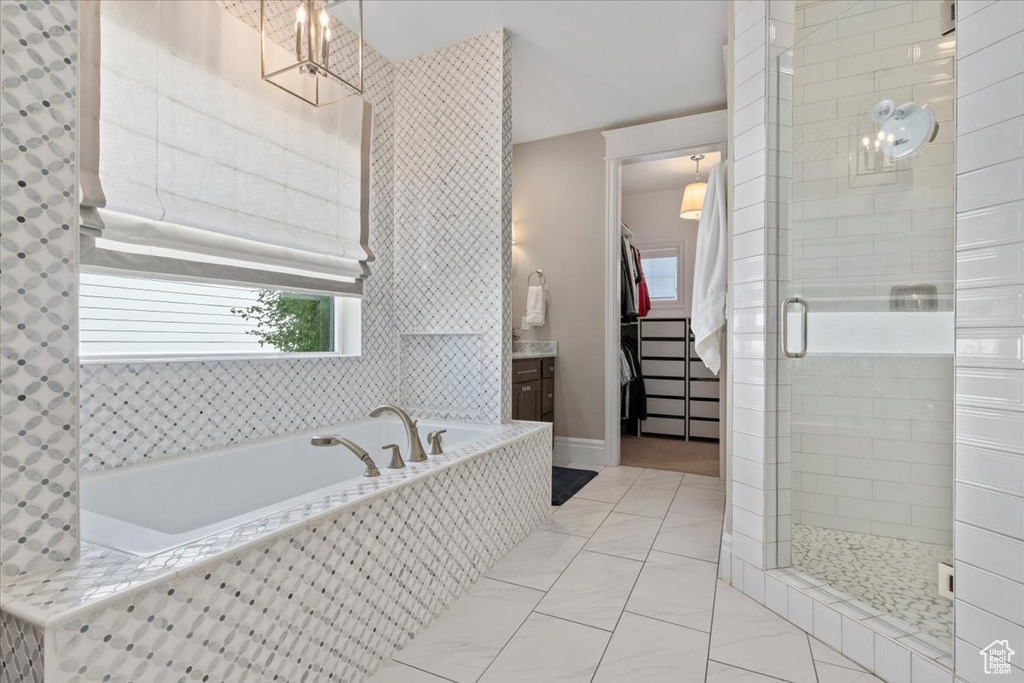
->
[75,2,397,470]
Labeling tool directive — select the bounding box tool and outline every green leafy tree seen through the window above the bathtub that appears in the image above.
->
[231,290,334,353]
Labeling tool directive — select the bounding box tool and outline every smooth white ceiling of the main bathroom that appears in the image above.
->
[364,0,727,142]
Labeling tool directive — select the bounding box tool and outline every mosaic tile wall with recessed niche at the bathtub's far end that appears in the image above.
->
[394,30,512,422]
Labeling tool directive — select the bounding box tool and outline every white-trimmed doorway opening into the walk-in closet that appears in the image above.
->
[605,112,728,477]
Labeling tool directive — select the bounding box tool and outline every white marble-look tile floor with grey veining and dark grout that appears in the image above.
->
[371,465,879,683]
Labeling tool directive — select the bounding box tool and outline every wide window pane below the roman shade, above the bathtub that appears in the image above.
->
[79,272,360,358]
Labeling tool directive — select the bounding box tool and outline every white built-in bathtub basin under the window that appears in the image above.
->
[80,417,498,557]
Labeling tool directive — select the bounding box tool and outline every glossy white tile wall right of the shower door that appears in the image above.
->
[954,0,1024,681]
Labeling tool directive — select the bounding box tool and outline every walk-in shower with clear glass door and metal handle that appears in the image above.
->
[768,0,955,665]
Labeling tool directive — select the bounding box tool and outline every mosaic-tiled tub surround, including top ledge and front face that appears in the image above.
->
[2,423,551,683]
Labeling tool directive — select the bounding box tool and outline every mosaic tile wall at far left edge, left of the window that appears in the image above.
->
[0,0,78,577]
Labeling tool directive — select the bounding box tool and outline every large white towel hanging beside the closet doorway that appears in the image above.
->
[690,164,728,375]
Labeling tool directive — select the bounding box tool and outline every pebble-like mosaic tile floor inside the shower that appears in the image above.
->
[793,524,953,652]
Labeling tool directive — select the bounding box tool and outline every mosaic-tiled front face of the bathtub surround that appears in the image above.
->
[46,428,551,681]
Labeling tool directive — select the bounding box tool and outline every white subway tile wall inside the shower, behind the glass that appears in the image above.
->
[779,0,955,546]
